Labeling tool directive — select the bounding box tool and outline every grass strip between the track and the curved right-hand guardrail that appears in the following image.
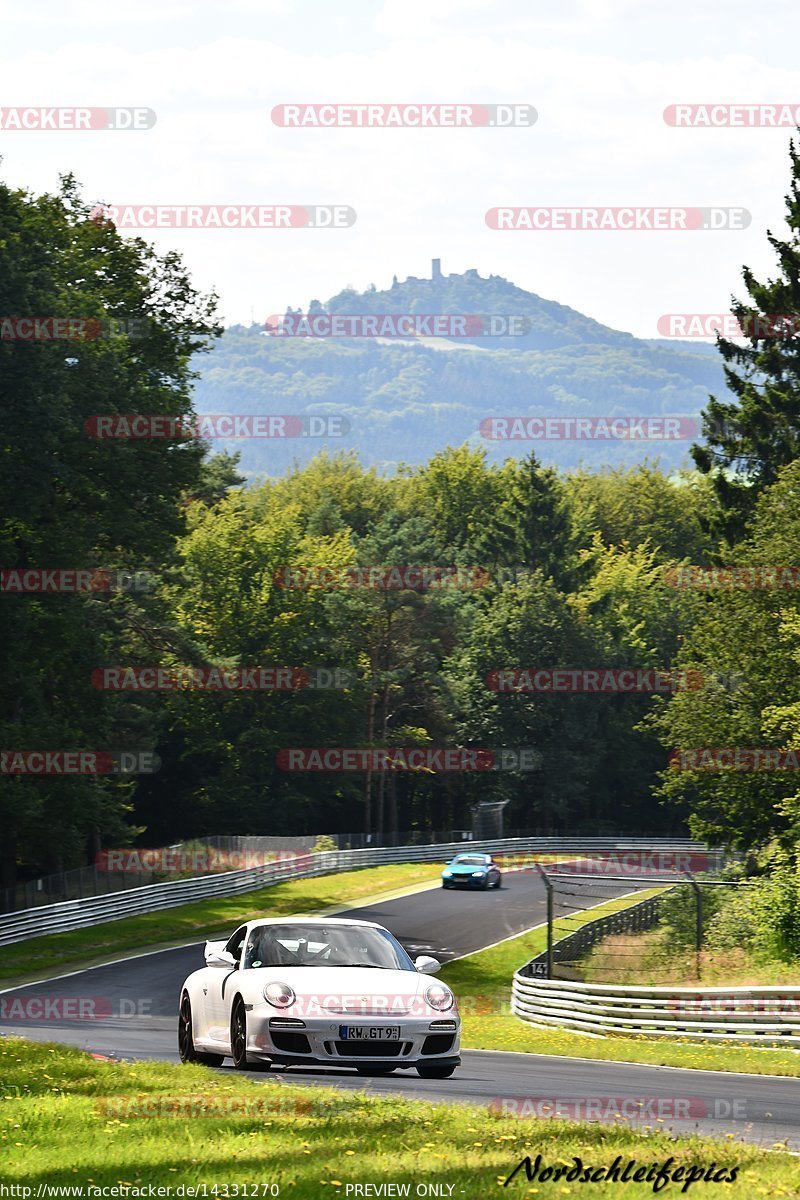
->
[441,888,800,1076]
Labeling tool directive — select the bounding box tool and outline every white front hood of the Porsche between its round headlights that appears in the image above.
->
[242,966,455,1016]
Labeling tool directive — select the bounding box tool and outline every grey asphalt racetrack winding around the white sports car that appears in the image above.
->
[0,872,800,1151]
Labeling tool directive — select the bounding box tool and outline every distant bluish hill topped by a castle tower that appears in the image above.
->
[190,263,726,475]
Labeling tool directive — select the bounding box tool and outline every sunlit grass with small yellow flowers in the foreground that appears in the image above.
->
[0,1038,800,1200]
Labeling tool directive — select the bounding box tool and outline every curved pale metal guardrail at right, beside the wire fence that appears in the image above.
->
[511,896,800,1046]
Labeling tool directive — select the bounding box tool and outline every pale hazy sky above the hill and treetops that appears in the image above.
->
[0,0,800,337]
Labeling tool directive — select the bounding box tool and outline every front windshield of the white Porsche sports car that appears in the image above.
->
[245,923,416,971]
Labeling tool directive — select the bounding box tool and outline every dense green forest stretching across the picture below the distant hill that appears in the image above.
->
[0,142,800,882]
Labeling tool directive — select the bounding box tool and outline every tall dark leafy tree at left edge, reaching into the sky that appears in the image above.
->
[0,176,217,884]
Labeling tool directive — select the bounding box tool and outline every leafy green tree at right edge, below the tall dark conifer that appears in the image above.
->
[651,462,800,848]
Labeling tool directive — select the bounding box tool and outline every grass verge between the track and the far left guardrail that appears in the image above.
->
[0,863,441,985]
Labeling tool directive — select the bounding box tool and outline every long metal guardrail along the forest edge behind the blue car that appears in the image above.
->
[0,838,721,946]
